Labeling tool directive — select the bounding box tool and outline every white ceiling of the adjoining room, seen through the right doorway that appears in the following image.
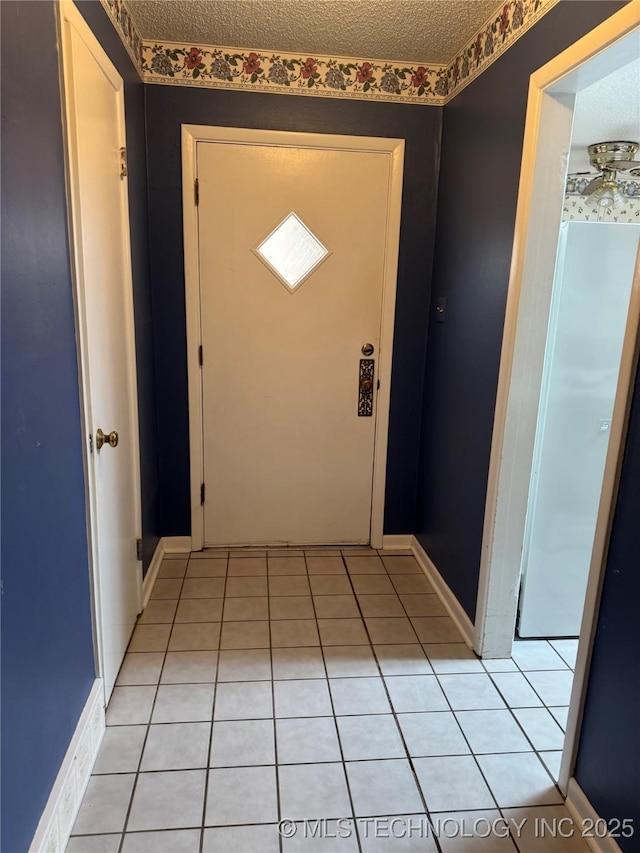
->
[569,59,640,173]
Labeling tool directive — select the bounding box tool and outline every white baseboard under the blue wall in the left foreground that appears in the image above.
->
[29,678,105,853]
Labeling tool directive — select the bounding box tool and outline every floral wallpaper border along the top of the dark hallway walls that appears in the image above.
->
[101,0,559,106]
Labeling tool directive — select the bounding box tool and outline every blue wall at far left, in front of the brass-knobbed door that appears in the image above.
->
[0,0,94,853]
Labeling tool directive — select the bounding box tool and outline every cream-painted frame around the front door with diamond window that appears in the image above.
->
[182,125,404,551]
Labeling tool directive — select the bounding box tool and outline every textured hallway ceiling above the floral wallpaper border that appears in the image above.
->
[128,0,501,65]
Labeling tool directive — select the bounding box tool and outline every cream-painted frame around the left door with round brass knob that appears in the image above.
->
[58,0,142,678]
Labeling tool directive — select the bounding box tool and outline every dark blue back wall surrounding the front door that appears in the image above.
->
[147,86,441,535]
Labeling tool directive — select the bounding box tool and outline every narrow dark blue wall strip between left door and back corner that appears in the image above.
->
[76,0,161,572]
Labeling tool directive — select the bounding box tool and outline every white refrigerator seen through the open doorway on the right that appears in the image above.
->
[518,222,640,637]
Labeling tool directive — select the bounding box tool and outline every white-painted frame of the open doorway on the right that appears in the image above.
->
[474,3,640,791]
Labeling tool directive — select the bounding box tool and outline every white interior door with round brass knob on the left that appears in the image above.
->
[62,3,141,699]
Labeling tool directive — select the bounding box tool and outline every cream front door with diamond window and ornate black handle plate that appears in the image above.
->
[196,134,398,545]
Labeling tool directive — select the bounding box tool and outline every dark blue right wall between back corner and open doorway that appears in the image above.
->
[415,0,624,619]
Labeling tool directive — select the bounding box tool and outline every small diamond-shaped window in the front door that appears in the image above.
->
[253,213,331,293]
